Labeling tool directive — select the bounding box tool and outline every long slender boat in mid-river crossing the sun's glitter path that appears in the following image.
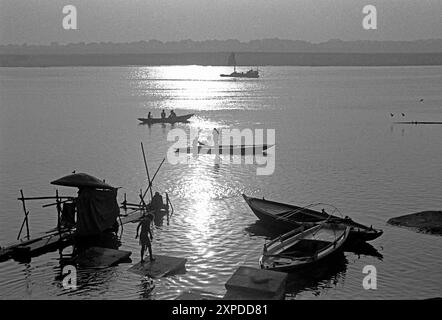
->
[175,144,271,156]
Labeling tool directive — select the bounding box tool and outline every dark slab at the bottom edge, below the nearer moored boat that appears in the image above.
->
[225,267,288,299]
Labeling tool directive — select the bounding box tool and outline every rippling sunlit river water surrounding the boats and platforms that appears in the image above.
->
[0,66,442,299]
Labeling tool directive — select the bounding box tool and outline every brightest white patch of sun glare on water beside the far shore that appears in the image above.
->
[127,66,256,111]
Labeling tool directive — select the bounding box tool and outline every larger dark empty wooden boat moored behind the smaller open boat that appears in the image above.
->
[243,194,383,241]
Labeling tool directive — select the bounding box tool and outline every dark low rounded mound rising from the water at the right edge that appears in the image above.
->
[387,211,442,235]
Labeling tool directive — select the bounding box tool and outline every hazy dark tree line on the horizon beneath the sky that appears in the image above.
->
[0,38,442,55]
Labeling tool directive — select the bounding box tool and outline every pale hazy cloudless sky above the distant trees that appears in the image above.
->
[0,0,442,44]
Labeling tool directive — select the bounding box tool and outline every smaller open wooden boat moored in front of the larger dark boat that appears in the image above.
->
[259,222,350,271]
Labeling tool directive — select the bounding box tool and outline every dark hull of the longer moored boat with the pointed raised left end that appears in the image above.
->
[243,194,383,242]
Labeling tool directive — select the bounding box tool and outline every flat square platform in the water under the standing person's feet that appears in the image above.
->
[129,255,187,278]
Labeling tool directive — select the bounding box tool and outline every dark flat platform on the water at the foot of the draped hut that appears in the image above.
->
[74,247,132,268]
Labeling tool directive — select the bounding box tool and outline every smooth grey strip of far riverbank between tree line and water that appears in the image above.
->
[0,52,442,67]
